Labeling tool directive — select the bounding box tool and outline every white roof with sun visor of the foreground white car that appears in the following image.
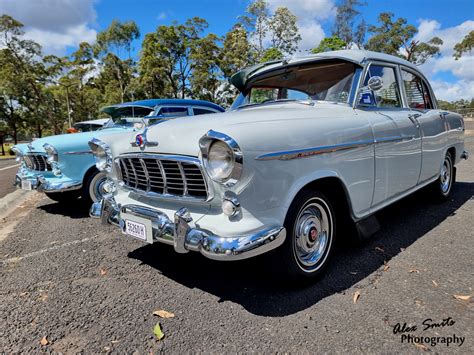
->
[230,49,419,91]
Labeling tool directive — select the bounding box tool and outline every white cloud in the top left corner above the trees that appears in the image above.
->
[0,0,97,54]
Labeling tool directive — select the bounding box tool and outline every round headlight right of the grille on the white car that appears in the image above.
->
[207,141,234,181]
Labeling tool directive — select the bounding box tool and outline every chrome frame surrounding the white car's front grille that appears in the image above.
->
[115,153,214,203]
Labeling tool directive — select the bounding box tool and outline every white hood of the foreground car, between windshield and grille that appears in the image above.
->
[106,102,360,156]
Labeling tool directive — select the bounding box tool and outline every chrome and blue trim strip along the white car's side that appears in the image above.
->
[255,136,415,160]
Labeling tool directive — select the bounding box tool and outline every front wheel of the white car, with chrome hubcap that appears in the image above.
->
[276,190,336,281]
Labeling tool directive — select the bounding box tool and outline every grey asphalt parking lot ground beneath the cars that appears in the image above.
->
[0,137,474,353]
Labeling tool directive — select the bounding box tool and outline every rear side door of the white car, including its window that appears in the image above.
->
[401,67,448,183]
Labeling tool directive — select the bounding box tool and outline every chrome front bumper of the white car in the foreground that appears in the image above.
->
[90,198,286,260]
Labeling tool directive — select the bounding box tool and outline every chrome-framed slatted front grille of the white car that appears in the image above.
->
[116,155,208,200]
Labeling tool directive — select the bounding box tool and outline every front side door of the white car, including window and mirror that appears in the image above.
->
[359,62,421,208]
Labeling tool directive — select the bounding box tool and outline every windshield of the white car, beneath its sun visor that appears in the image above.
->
[232,61,356,109]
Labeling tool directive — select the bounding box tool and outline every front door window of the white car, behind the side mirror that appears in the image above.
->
[360,65,402,108]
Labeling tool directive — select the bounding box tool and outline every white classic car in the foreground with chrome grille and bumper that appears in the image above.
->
[89,50,468,279]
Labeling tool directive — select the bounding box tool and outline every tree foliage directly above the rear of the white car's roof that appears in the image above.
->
[366,12,443,65]
